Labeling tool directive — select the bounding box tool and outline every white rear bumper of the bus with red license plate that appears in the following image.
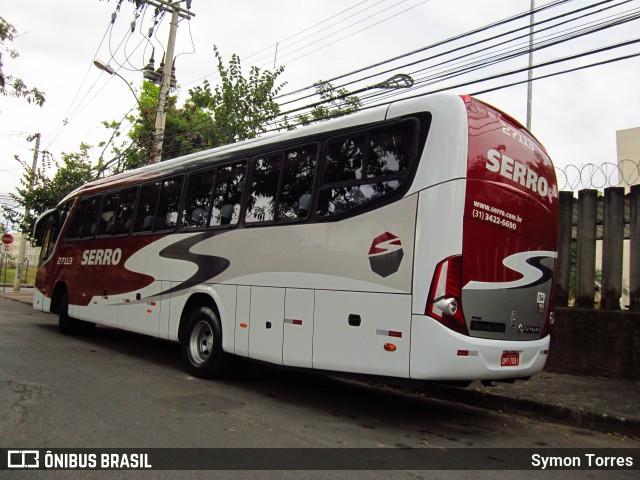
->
[409,315,550,381]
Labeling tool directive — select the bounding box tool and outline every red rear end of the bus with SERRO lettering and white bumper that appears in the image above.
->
[411,97,558,380]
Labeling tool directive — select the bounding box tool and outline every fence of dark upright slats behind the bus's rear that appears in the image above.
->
[555,185,640,311]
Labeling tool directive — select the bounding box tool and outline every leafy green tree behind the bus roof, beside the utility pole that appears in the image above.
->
[98,46,284,173]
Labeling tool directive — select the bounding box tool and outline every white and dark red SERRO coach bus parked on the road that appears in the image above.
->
[33,94,558,382]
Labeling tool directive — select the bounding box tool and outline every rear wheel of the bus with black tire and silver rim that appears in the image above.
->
[182,306,230,378]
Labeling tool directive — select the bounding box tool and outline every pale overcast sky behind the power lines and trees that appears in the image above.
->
[0,0,640,224]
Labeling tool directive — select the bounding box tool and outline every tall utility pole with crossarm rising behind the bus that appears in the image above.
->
[146,0,195,163]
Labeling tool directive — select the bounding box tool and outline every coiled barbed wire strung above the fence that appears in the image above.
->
[556,159,640,190]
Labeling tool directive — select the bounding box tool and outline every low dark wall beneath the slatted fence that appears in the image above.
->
[545,308,640,380]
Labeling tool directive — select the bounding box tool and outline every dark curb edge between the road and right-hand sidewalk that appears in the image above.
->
[425,385,640,438]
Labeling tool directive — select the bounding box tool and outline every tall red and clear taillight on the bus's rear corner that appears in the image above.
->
[425,255,469,335]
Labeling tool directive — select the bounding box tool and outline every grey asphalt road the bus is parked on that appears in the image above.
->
[0,299,640,479]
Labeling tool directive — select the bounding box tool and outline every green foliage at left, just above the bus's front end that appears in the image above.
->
[2,144,95,234]
